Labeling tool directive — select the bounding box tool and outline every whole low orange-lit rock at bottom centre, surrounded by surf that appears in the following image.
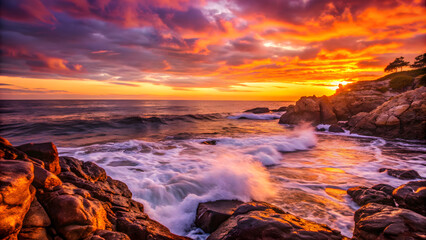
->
[195,200,346,240]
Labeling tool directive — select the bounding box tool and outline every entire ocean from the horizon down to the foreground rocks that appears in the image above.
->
[0,100,426,239]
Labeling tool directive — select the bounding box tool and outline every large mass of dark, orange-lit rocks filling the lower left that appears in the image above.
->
[0,138,188,240]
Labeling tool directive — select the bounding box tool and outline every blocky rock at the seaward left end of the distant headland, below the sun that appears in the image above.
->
[279,96,337,125]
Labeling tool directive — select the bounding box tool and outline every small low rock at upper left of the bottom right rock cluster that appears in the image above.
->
[347,187,395,206]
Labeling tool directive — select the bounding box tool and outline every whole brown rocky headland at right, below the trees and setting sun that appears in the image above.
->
[279,68,426,140]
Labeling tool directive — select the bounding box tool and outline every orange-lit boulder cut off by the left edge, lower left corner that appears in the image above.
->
[0,160,35,239]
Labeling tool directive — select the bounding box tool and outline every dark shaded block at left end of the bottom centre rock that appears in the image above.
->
[195,200,243,233]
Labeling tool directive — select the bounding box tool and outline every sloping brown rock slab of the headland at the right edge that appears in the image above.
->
[350,87,426,139]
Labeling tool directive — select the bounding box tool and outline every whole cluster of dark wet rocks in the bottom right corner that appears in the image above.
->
[348,180,426,240]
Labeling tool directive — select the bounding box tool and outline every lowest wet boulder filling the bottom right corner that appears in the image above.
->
[354,203,426,240]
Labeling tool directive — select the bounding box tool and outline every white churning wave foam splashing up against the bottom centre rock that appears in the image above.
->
[59,125,316,234]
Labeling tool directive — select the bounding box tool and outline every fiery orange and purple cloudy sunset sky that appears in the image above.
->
[0,0,426,101]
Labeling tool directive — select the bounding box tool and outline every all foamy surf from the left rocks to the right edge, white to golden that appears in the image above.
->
[59,125,426,239]
